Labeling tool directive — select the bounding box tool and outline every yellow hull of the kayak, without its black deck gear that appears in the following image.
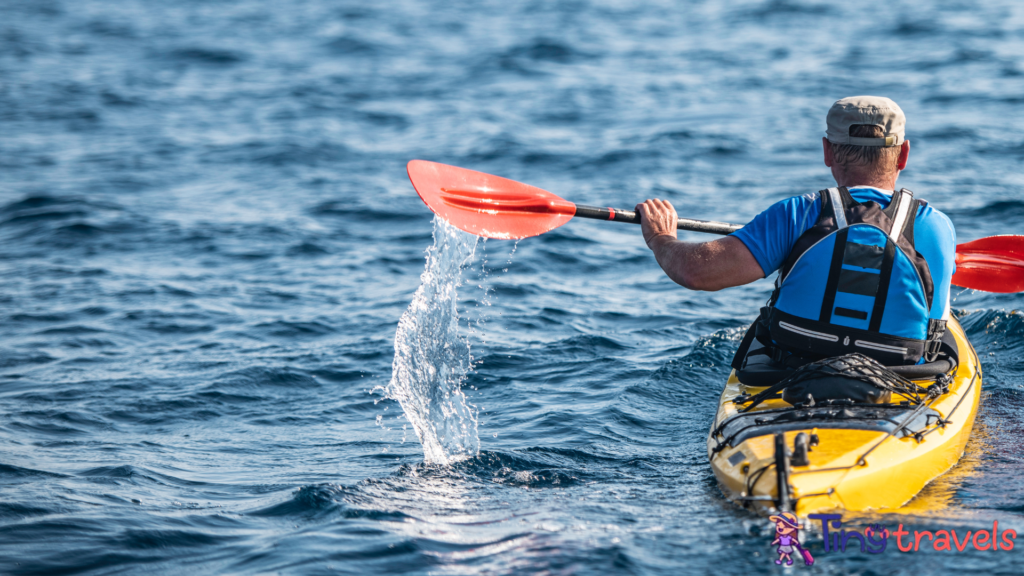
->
[708,319,981,516]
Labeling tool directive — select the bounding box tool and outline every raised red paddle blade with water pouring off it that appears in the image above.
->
[407,160,575,240]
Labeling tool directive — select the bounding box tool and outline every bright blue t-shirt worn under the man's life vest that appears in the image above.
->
[732,187,956,319]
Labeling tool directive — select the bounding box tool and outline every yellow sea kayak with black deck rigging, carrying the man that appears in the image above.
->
[708,319,981,517]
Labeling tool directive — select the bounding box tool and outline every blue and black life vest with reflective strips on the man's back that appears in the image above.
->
[733,187,945,369]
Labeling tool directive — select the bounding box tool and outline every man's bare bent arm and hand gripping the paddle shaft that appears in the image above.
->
[637,200,765,291]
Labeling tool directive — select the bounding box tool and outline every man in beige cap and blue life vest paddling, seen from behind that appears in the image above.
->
[637,96,956,367]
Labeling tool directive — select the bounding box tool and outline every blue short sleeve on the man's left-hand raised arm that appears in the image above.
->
[732,193,821,278]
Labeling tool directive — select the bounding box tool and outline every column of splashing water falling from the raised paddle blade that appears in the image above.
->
[383,217,480,464]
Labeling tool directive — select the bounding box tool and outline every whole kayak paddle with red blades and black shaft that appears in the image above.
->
[408,160,1024,293]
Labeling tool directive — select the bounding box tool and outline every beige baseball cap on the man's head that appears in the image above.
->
[825,96,906,148]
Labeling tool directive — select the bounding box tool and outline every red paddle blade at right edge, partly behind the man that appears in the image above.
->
[952,235,1024,293]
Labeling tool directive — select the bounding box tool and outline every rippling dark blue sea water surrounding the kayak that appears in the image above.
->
[0,0,1024,574]
